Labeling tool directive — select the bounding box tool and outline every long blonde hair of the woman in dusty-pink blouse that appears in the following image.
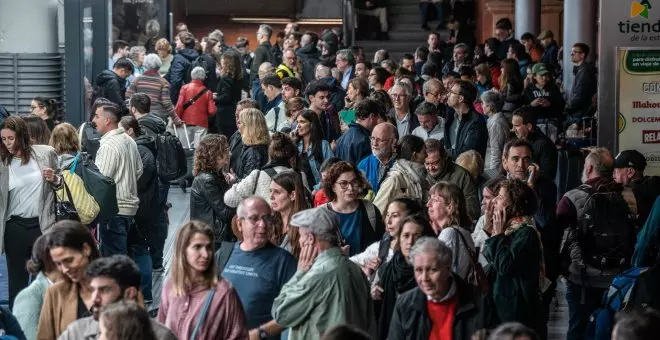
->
[171,221,218,296]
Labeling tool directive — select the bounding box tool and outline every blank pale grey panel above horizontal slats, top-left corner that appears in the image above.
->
[0,0,58,53]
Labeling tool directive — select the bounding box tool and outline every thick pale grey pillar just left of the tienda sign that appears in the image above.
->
[563,0,598,93]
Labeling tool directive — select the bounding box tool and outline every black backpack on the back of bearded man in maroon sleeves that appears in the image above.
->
[578,185,635,270]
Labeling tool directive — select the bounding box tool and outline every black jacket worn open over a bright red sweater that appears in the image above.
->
[388,273,497,340]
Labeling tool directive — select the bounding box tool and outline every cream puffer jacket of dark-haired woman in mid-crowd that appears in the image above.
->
[374,159,429,211]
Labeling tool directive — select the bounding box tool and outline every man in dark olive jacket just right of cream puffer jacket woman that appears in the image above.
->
[424,139,481,220]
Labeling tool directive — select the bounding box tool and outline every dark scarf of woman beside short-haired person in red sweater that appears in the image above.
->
[377,250,417,340]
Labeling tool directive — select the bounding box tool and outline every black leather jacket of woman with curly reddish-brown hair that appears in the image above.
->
[190,172,235,241]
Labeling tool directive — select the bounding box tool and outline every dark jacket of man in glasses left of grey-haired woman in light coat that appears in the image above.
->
[444,109,488,160]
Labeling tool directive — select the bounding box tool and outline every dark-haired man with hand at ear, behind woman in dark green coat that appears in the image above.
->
[502,139,563,337]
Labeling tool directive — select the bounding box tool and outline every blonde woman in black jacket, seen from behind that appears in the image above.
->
[236,109,270,179]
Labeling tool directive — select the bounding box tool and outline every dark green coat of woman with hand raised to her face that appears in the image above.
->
[484,225,542,327]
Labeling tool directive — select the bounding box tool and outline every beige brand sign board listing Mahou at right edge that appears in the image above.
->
[617,48,660,175]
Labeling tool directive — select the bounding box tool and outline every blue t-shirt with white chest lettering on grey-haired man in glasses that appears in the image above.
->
[222,243,297,338]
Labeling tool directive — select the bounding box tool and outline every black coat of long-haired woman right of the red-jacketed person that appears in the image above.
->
[215,77,242,138]
